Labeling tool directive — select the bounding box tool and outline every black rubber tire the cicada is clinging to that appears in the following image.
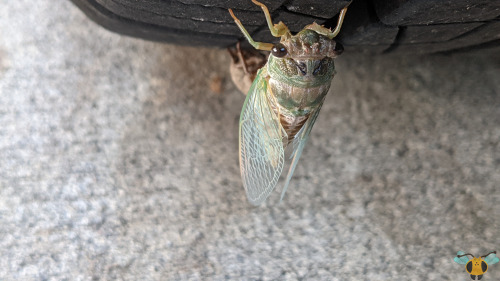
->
[71,0,500,53]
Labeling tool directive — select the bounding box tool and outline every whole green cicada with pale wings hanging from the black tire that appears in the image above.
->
[229,0,347,205]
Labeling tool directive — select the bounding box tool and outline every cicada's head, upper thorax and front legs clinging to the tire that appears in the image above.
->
[229,0,347,88]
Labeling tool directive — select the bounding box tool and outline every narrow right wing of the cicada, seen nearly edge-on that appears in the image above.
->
[280,99,324,201]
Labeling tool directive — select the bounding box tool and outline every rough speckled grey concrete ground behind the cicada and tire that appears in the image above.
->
[0,0,500,280]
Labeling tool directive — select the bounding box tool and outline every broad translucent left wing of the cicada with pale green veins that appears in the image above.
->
[239,69,286,205]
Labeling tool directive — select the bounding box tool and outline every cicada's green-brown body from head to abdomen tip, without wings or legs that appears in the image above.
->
[266,29,342,144]
